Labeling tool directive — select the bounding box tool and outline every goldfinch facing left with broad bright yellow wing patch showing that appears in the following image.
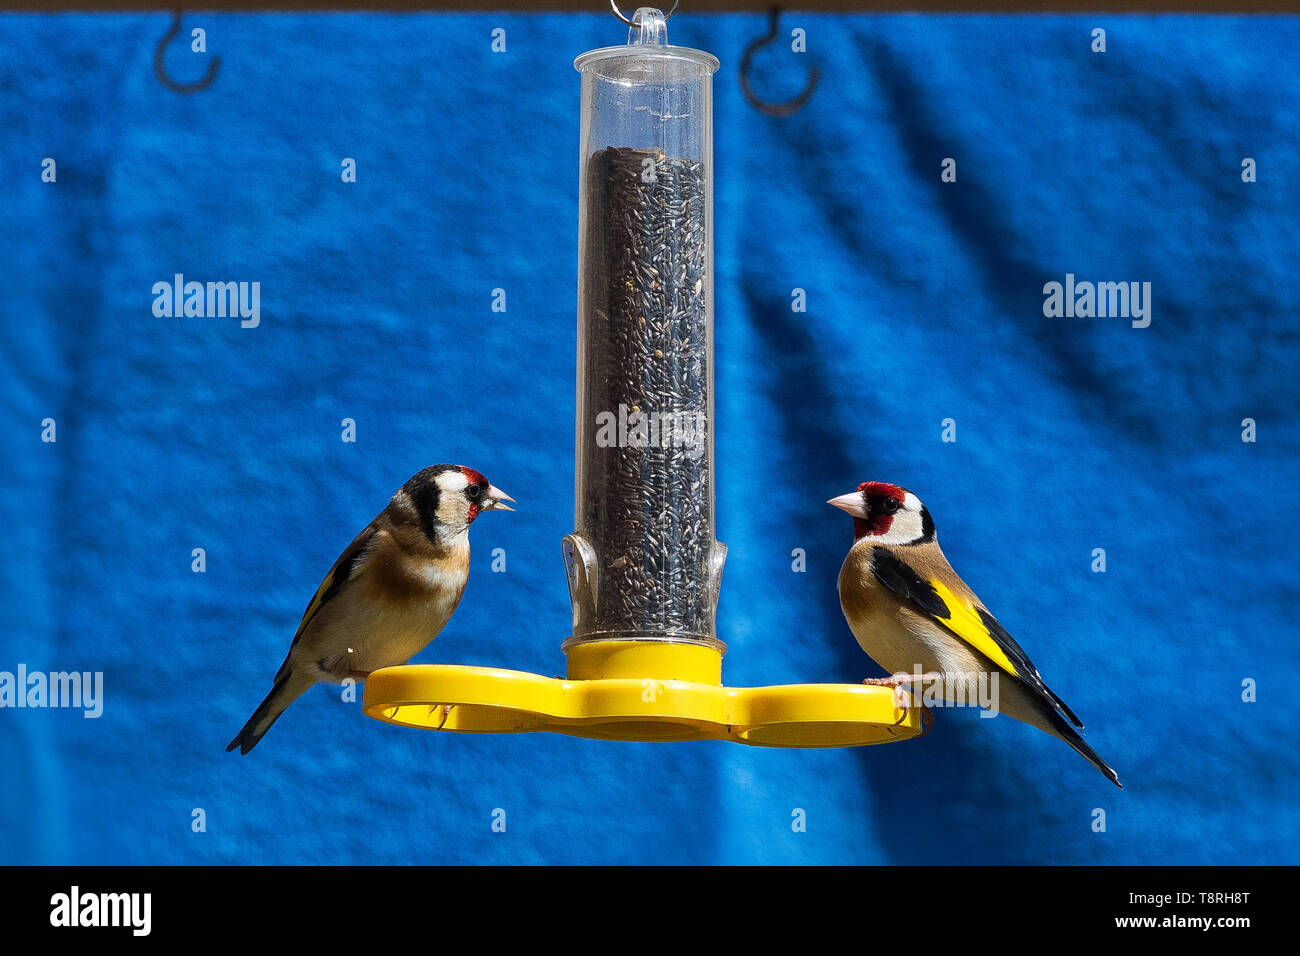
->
[827,481,1123,790]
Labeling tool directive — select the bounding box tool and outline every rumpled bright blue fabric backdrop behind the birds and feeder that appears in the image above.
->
[0,14,1300,864]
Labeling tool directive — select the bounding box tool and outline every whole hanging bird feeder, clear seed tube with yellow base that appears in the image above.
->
[364,8,920,747]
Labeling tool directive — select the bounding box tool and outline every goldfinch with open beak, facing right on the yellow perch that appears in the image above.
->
[226,464,515,753]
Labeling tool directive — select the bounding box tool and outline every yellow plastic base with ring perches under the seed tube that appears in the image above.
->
[363,641,922,747]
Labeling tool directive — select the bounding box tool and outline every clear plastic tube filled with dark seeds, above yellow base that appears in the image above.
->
[564,8,727,648]
